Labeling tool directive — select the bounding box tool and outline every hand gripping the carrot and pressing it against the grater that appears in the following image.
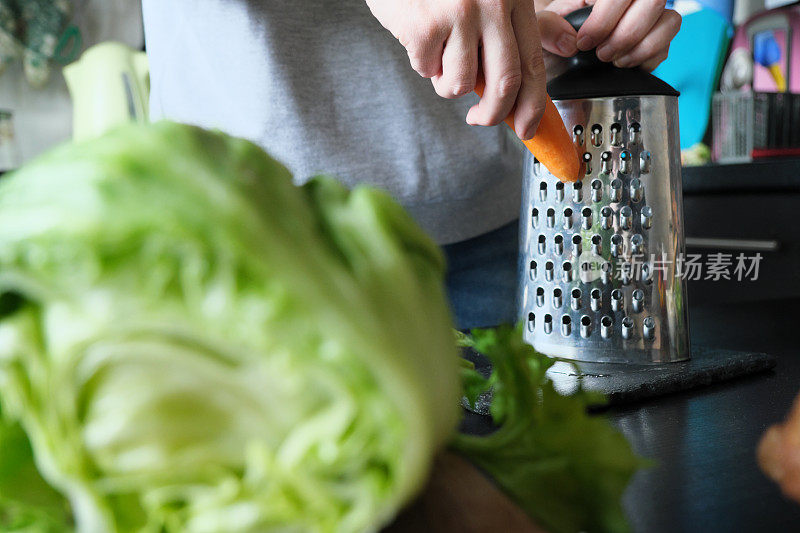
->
[366,0,578,140]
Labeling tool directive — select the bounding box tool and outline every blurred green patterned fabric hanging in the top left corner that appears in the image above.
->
[0,0,80,87]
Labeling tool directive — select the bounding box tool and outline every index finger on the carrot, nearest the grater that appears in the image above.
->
[511,8,548,140]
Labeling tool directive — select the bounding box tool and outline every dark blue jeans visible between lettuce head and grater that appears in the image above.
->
[442,221,519,329]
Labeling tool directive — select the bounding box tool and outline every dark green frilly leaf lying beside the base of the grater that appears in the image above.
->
[452,326,644,533]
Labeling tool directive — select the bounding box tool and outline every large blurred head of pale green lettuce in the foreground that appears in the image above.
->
[0,123,458,532]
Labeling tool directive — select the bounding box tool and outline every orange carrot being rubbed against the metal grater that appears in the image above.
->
[475,77,581,181]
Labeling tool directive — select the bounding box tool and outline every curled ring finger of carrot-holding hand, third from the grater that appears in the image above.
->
[431,29,478,98]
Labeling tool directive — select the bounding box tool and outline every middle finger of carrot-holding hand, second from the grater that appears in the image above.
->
[467,17,522,126]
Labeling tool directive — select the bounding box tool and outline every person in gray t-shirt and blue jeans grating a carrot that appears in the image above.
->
[143,0,680,329]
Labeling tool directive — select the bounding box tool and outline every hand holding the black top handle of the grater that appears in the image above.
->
[536,0,681,70]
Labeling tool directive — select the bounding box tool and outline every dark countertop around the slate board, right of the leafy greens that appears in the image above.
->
[607,300,800,533]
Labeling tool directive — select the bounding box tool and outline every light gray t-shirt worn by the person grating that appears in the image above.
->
[143,0,522,244]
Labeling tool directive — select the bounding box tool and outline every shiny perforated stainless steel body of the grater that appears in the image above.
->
[519,96,689,364]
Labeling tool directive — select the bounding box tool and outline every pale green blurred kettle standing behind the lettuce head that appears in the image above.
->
[64,42,150,140]
